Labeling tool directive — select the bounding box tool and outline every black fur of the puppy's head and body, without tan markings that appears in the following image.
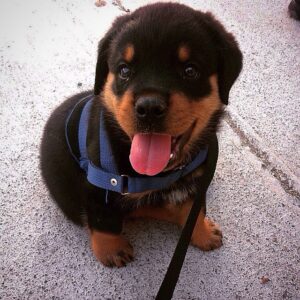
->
[41,3,242,232]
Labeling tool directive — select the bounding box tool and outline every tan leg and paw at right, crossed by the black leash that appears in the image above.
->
[130,198,222,251]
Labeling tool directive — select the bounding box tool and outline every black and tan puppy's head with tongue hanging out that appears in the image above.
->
[95,3,242,175]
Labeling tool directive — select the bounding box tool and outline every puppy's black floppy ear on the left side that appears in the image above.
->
[94,15,130,96]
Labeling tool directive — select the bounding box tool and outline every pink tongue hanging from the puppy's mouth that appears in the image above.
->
[129,133,171,176]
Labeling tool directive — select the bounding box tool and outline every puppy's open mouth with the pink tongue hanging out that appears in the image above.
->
[129,123,195,176]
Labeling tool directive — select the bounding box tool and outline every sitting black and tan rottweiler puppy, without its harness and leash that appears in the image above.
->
[41,3,242,267]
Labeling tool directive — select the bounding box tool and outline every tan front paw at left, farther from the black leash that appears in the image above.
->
[91,231,133,267]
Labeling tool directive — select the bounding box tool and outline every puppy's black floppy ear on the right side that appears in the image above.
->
[205,13,243,104]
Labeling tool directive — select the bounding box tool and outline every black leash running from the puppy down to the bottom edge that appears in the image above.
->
[155,135,219,300]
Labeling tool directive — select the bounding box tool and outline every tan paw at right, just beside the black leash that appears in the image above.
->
[191,217,222,251]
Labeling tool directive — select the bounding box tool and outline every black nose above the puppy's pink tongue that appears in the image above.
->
[135,96,167,120]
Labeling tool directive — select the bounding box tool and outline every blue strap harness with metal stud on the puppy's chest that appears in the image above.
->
[65,95,208,194]
